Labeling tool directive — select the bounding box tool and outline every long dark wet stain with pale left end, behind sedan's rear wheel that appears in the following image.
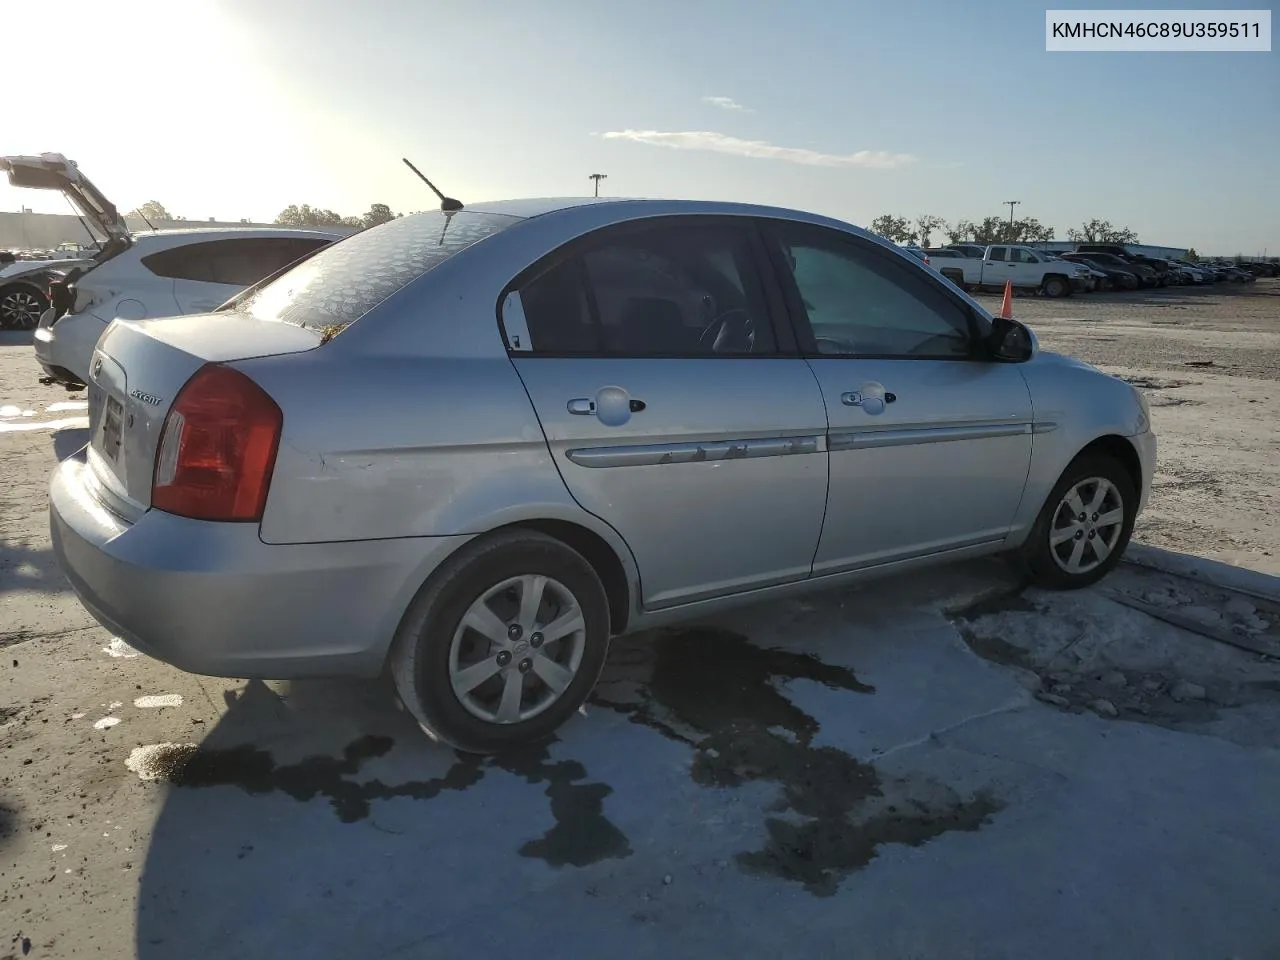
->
[131,736,484,823]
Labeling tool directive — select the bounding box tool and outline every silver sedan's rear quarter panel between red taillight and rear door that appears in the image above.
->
[244,348,586,544]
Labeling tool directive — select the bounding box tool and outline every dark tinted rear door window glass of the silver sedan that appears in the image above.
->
[507,223,774,357]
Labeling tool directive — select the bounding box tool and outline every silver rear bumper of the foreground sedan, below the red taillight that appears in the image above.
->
[49,460,470,680]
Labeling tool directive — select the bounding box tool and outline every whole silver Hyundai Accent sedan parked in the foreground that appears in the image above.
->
[50,200,1156,753]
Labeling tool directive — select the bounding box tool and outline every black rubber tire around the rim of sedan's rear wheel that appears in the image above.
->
[389,530,609,754]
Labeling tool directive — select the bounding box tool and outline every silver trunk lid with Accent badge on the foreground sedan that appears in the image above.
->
[86,312,321,521]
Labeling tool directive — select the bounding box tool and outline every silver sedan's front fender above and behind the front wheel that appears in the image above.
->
[1010,353,1144,544]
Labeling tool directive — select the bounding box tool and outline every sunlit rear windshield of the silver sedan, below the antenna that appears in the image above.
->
[237,210,518,335]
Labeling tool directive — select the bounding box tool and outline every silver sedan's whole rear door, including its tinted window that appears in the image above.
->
[502,216,827,608]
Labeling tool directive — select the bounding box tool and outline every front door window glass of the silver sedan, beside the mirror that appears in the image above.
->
[778,229,970,358]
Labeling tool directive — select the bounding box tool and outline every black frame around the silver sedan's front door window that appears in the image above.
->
[759,219,992,364]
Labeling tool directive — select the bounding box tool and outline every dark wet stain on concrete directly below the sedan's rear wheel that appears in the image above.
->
[493,746,632,867]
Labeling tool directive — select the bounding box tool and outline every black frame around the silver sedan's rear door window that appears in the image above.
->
[494,214,800,360]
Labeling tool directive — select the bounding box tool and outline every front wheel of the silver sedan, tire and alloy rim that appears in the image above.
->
[1021,454,1138,590]
